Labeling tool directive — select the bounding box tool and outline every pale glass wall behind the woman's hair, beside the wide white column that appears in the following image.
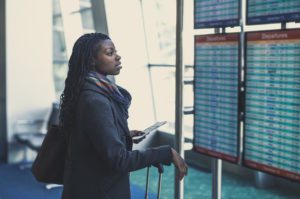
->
[52,0,95,100]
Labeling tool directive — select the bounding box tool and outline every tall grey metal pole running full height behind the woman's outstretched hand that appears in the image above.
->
[174,0,184,199]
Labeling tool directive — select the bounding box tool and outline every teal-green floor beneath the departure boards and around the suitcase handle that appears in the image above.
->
[131,166,300,199]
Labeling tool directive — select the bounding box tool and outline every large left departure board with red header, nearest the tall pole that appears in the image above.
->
[193,34,240,162]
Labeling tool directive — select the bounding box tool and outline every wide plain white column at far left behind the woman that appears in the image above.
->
[5,0,55,145]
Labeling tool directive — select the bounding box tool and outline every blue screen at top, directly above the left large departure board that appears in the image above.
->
[194,0,240,28]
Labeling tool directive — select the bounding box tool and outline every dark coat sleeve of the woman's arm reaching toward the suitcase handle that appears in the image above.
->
[82,95,172,172]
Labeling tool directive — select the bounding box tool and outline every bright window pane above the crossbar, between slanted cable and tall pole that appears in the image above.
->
[142,0,176,64]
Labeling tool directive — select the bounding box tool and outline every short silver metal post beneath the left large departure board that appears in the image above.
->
[212,158,222,199]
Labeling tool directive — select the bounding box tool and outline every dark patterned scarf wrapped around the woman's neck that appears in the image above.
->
[86,71,131,119]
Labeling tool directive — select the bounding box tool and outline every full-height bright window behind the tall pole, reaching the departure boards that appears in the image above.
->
[142,0,194,138]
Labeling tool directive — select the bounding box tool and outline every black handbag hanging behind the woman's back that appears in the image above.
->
[31,125,67,184]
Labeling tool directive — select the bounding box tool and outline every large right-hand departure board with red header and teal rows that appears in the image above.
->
[244,29,300,181]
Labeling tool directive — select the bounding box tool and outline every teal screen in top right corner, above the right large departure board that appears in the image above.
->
[247,0,300,25]
